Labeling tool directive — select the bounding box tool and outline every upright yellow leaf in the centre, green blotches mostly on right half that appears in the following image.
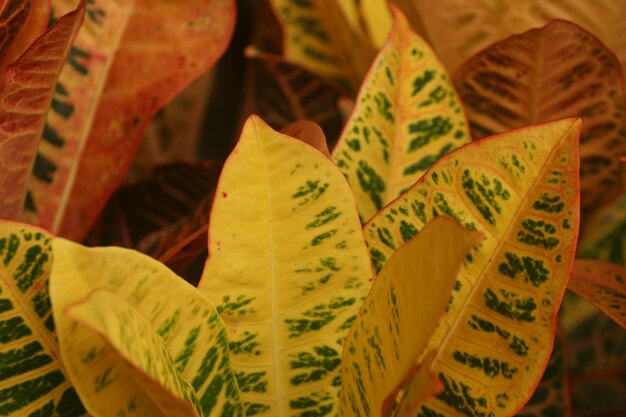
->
[199,116,372,417]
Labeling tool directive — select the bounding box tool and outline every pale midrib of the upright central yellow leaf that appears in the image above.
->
[254,120,284,416]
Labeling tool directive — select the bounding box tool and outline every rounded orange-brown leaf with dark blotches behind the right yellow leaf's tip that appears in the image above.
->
[454,21,626,220]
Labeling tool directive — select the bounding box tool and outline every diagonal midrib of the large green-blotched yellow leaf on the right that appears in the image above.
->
[428,122,578,370]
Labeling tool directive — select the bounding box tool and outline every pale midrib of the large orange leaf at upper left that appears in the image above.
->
[51,0,136,233]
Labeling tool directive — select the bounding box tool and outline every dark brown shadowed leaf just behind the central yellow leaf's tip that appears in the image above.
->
[242,48,343,148]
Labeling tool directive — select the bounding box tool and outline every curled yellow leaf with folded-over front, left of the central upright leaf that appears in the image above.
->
[50,238,244,417]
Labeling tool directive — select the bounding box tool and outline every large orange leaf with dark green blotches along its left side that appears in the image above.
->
[26,0,234,239]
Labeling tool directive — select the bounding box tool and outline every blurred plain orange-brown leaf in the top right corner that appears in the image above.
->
[394,0,626,71]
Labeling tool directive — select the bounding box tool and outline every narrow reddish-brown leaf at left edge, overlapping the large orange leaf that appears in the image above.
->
[0,2,85,219]
